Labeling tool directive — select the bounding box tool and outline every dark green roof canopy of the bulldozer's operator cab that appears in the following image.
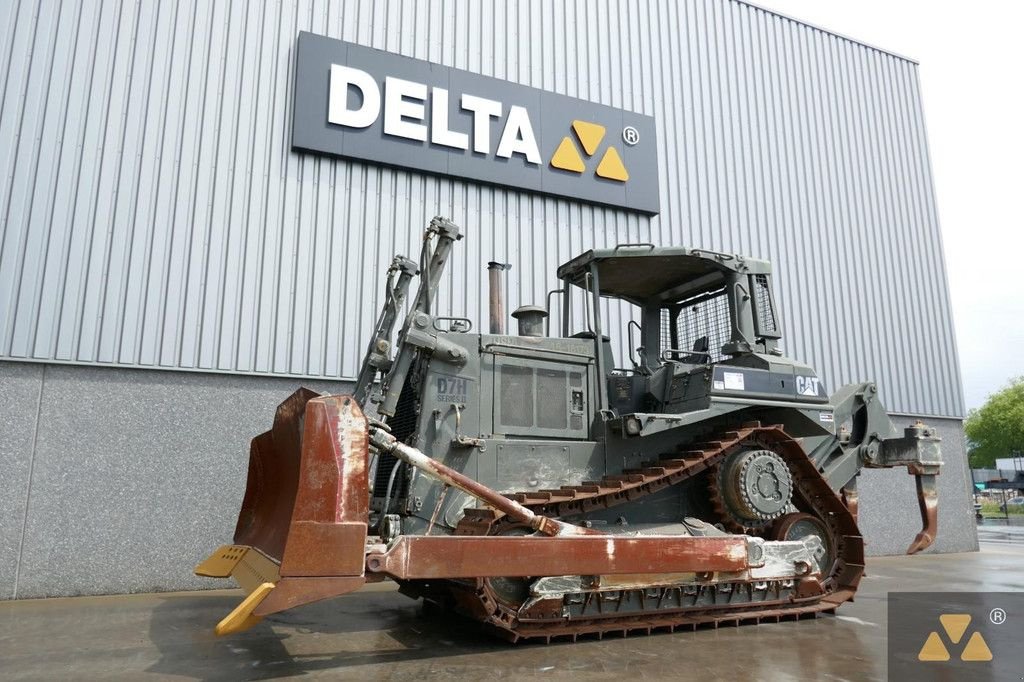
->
[558,245,771,305]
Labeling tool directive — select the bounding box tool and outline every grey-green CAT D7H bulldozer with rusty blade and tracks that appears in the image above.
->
[196,217,942,642]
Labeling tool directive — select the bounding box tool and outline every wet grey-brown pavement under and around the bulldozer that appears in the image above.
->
[0,536,1024,680]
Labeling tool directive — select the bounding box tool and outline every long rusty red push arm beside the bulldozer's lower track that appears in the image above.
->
[367,536,750,579]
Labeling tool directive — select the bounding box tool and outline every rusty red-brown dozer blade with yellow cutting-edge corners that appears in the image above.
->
[196,388,369,635]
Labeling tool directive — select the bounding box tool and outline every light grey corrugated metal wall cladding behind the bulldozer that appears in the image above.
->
[0,0,963,416]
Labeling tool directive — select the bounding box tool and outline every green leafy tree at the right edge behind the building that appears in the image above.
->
[964,377,1024,469]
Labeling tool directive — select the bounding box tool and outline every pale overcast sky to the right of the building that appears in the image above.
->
[755,0,1024,409]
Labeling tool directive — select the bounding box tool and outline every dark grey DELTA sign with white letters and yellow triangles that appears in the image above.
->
[292,32,659,214]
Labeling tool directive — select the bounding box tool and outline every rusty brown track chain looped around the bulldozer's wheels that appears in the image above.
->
[434,422,864,641]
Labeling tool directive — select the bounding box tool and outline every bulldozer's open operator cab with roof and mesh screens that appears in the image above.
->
[558,245,793,414]
